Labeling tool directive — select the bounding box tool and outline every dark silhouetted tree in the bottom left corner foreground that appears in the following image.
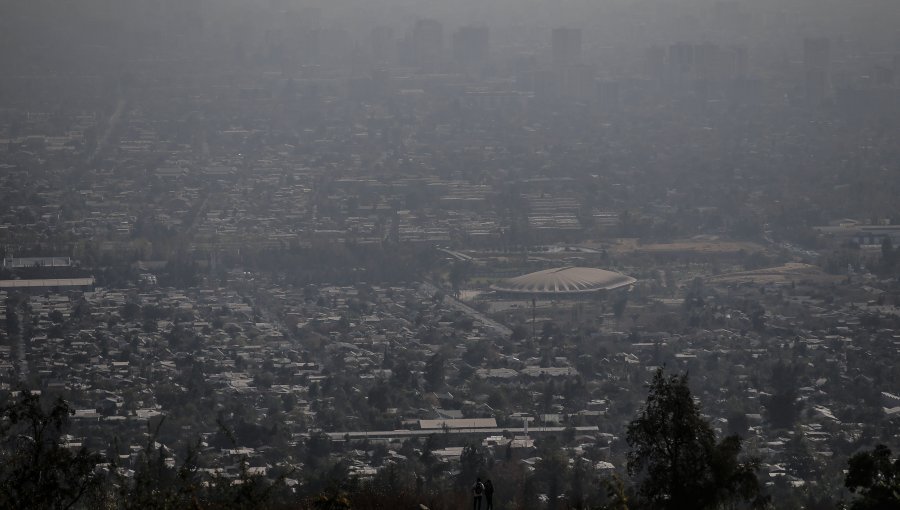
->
[0,391,102,509]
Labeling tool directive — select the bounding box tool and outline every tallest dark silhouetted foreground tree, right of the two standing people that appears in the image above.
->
[627,369,759,509]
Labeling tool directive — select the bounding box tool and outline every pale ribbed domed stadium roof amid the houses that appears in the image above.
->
[491,267,637,297]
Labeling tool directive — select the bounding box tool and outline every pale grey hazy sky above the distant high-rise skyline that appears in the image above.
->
[0,0,900,77]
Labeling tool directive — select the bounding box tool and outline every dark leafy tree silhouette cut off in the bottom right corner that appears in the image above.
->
[844,444,900,510]
